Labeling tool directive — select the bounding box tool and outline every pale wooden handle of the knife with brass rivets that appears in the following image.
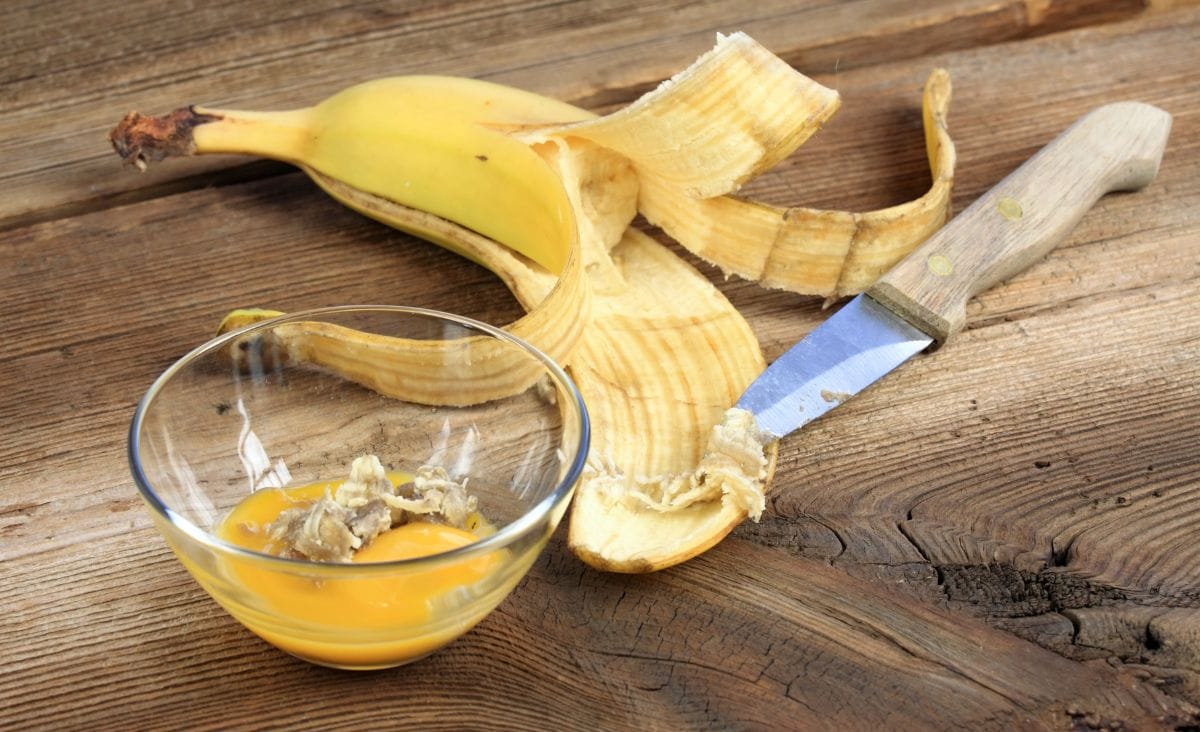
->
[866,102,1171,344]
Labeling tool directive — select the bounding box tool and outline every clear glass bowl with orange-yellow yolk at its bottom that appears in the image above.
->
[128,306,589,668]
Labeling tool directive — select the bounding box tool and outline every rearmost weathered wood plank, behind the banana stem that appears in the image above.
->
[0,0,1161,227]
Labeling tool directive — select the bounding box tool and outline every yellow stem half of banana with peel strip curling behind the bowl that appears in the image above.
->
[110,77,589,404]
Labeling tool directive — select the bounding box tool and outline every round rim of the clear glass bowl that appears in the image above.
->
[126,305,592,575]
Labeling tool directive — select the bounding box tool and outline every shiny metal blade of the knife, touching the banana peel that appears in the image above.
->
[738,295,934,438]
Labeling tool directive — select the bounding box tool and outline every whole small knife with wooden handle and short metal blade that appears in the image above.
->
[737,102,1171,439]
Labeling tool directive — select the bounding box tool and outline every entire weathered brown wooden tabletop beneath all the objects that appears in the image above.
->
[0,0,1200,730]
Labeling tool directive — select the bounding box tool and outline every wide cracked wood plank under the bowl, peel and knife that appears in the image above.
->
[0,4,1200,728]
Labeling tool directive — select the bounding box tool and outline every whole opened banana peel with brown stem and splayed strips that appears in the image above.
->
[110,34,954,572]
